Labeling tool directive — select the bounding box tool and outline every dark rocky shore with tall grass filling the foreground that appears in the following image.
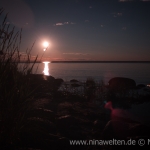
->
[0,9,150,150]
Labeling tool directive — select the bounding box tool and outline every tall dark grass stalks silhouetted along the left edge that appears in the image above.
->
[0,9,37,146]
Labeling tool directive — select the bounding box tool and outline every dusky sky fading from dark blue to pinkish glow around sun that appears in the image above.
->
[0,0,150,61]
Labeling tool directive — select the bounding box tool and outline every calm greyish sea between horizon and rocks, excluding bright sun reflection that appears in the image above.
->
[29,63,150,84]
